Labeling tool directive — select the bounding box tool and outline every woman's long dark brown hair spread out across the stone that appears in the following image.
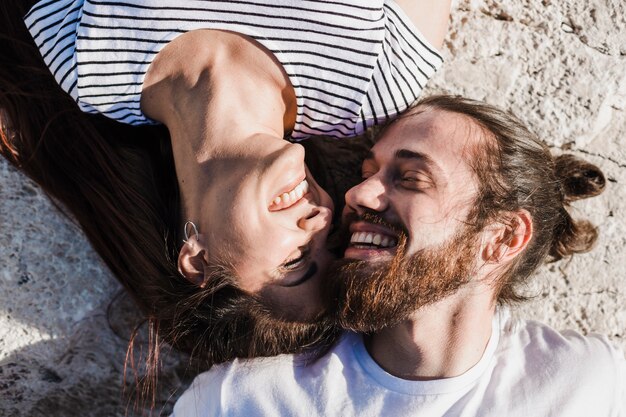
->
[0,0,336,410]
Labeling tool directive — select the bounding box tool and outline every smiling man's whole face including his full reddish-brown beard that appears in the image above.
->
[329,110,481,332]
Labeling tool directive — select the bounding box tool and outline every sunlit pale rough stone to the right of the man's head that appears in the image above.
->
[429,0,626,349]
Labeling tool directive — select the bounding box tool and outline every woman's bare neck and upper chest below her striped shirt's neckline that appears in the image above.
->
[141,30,296,157]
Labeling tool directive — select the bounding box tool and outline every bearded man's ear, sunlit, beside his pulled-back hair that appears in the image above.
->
[481,210,533,263]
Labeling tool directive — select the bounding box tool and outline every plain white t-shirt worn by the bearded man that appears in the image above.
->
[173,310,626,417]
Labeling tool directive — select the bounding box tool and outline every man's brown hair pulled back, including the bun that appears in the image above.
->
[394,95,606,303]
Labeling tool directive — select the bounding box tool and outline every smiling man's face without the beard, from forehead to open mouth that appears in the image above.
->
[343,109,482,261]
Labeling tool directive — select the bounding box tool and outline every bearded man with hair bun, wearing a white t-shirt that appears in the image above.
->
[174,96,626,417]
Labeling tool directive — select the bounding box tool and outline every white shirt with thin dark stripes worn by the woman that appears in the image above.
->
[24,0,442,139]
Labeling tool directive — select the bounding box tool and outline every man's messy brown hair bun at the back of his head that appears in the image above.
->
[550,154,606,261]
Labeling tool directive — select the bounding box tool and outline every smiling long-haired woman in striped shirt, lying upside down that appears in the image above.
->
[2,0,449,402]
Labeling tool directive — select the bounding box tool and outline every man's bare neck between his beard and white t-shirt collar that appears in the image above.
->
[366,291,495,380]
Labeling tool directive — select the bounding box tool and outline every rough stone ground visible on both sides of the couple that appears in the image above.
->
[0,0,626,417]
